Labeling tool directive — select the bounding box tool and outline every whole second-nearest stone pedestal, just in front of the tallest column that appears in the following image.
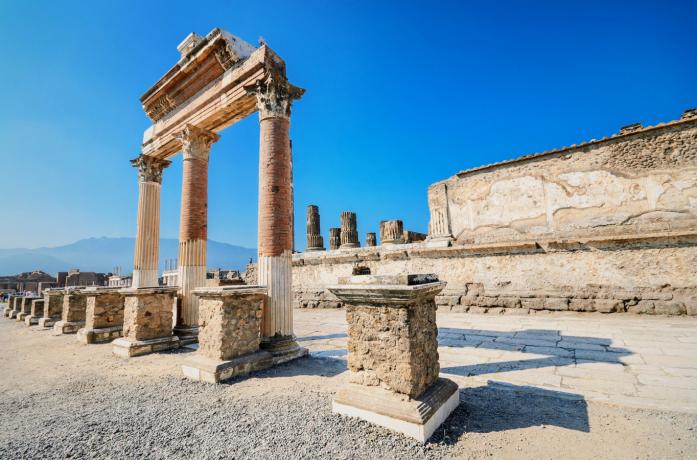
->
[182,286,307,383]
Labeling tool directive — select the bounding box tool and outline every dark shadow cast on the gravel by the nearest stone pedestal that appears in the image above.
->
[431,381,590,444]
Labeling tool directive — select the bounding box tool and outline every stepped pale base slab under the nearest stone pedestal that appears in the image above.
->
[332,378,460,443]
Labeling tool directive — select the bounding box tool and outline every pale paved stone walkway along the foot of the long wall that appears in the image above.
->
[294,310,697,413]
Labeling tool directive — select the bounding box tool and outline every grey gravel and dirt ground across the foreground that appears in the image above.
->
[0,312,697,459]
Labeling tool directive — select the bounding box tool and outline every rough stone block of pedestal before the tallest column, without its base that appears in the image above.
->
[197,288,265,360]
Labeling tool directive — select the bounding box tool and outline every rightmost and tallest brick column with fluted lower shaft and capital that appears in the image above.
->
[247,74,304,351]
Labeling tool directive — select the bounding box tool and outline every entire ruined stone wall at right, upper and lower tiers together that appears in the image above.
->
[293,115,697,315]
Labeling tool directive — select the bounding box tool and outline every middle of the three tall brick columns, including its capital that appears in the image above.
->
[174,124,220,344]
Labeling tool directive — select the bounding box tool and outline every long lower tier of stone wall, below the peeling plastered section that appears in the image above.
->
[293,228,697,315]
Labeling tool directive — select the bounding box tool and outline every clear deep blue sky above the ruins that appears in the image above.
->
[0,0,697,249]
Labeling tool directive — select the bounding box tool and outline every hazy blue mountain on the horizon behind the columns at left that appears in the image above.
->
[0,237,257,275]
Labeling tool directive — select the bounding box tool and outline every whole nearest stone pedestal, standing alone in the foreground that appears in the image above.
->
[329,275,459,442]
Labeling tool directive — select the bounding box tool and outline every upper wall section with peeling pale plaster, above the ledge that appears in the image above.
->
[428,116,697,244]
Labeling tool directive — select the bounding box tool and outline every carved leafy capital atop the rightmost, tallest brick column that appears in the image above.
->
[244,73,305,121]
